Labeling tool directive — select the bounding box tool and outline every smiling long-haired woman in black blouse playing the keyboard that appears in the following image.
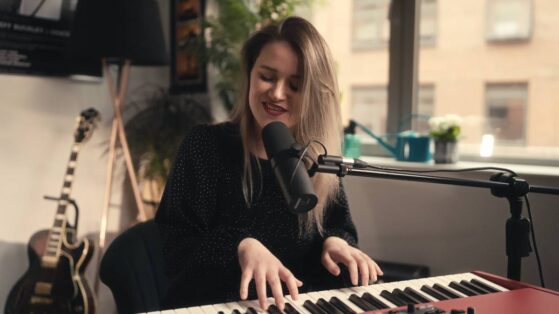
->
[156,17,382,309]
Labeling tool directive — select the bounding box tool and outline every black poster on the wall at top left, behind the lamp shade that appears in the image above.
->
[0,0,101,76]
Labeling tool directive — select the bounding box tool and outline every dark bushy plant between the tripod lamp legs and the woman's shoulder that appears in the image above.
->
[125,88,212,216]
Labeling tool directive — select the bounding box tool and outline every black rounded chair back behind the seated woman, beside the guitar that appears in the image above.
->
[99,220,169,313]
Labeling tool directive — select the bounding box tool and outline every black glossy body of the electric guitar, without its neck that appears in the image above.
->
[5,229,95,314]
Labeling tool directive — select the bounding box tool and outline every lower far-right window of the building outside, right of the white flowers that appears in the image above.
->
[485,83,528,144]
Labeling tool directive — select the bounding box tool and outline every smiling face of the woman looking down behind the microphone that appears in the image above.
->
[248,41,302,131]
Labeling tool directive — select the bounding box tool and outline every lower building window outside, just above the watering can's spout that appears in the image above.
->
[351,86,388,138]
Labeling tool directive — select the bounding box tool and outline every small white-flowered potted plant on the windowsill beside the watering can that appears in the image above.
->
[429,114,462,164]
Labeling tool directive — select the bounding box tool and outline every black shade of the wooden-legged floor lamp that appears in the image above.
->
[69,0,169,65]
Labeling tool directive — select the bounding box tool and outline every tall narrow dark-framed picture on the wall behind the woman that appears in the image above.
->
[171,0,207,94]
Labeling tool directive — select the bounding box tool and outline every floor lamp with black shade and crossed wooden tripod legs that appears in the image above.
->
[69,0,169,291]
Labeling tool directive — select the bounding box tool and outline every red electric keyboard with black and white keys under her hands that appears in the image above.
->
[149,272,559,314]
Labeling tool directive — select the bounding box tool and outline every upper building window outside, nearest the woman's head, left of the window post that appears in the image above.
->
[351,0,390,50]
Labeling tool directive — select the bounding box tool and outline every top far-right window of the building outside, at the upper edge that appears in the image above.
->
[486,0,532,41]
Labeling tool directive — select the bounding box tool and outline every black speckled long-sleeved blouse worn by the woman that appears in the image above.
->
[155,122,357,307]
